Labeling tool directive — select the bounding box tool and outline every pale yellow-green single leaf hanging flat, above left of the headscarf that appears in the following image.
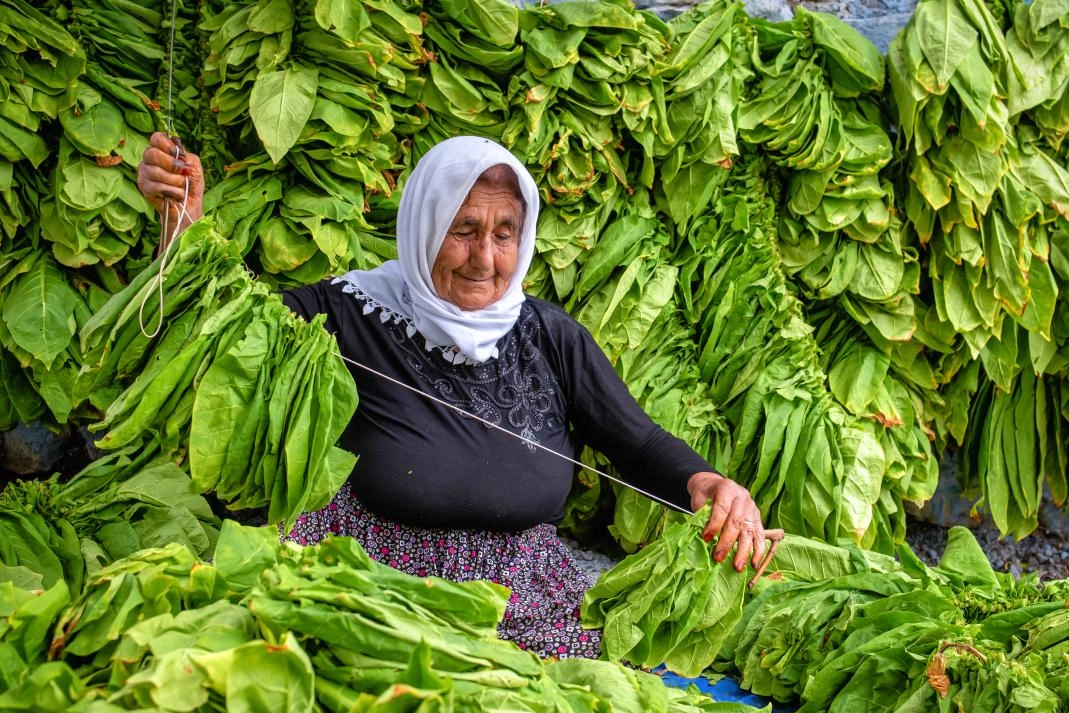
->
[249,67,320,165]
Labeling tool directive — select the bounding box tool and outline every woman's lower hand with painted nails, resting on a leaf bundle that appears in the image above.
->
[686,472,764,572]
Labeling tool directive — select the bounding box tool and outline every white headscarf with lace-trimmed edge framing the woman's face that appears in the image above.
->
[340,136,539,362]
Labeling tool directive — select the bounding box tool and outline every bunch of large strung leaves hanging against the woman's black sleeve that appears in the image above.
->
[189,297,357,530]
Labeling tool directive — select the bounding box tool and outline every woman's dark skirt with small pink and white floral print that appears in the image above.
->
[286,483,601,658]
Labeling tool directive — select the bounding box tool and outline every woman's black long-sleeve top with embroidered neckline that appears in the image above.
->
[283,280,713,531]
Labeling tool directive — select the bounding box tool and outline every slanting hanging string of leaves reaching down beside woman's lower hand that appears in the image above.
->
[677,157,893,548]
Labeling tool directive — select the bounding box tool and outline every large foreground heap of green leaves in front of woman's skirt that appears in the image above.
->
[0,521,757,713]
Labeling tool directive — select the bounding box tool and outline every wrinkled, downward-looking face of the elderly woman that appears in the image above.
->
[431,180,523,310]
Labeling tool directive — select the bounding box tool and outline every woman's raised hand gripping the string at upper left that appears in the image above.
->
[137,131,204,249]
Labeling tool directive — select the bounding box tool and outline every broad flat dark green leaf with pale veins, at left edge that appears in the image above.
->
[2,258,78,367]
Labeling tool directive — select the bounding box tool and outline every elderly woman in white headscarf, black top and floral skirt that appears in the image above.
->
[138,134,764,656]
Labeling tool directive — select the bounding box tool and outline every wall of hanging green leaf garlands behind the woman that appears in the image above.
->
[0,0,1069,552]
